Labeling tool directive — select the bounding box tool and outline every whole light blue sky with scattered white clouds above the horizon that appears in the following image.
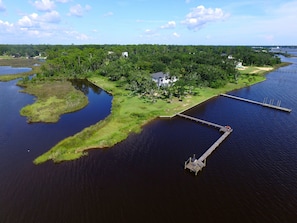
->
[0,0,297,45]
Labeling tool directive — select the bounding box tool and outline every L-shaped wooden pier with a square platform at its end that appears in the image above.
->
[176,113,233,175]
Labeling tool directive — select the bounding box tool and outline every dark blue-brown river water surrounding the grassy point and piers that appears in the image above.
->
[0,53,297,223]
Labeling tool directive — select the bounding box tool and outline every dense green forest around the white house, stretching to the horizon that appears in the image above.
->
[4,45,281,97]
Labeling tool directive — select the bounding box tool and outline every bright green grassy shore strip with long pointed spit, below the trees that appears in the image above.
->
[33,64,279,164]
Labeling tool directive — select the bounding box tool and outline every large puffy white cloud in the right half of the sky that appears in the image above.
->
[182,5,228,31]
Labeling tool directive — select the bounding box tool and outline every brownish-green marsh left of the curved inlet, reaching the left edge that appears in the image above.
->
[0,56,88,123]
